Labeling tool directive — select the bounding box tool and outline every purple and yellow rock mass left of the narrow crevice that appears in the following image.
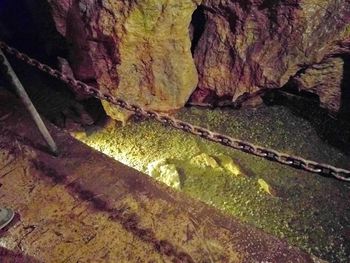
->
[49,0,198,118]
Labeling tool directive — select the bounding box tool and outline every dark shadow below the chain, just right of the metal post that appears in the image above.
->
[0,57,106,131]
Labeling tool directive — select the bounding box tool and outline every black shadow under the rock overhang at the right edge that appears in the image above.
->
[263,71,350,155]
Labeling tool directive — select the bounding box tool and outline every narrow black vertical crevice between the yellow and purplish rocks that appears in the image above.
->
[190,5,207,54]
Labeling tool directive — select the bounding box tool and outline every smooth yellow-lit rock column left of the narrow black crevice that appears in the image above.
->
[112,0,198,111]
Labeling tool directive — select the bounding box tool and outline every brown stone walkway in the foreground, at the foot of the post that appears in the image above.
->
[0,92,313,262]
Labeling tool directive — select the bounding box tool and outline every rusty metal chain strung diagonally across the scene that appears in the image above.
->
[0,41,350,182]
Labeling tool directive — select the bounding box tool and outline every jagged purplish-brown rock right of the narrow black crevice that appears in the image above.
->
[192,0,350,112]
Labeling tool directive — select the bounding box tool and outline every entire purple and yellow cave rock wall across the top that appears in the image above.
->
[8,0,350,118]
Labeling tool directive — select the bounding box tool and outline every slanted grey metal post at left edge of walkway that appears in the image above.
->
[0,49,58,155]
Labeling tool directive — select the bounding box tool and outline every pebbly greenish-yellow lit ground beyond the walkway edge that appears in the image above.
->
[72,100,350,263]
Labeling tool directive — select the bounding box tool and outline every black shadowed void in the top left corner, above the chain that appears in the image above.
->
[0,0,67,65]
